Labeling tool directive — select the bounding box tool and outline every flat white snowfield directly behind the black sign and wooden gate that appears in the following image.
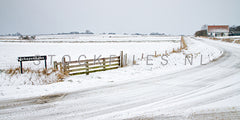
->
[0,42,180,69]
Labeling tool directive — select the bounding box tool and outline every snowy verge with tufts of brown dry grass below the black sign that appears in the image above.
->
[0,68,65,86]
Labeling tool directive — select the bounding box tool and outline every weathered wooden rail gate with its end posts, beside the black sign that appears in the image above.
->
[54,51,124,75]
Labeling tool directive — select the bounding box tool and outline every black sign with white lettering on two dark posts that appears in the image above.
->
[18,56,47,73]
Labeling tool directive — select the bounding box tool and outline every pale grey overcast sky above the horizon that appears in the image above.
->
[0,0,240,34]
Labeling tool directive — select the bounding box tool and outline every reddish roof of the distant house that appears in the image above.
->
[208,25,229,32]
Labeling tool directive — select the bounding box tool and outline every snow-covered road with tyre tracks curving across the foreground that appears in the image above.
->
[0,37,240,120]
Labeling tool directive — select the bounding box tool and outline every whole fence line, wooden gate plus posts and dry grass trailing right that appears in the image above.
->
[54,36,187,75]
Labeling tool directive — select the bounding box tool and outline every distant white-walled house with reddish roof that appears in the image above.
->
[207,25,229,37]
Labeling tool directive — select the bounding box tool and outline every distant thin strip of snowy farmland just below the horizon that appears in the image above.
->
[0,34,180,43]
